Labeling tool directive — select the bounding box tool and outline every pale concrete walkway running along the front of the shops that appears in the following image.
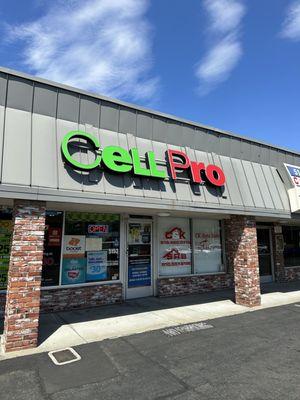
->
[0,282,300,360]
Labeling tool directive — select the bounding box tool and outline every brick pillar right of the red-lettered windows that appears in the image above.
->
[225,215,261,307]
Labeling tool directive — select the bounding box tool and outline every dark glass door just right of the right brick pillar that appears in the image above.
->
[257,227,274,283]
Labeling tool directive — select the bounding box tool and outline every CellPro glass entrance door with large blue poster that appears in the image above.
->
[126,219,153,299]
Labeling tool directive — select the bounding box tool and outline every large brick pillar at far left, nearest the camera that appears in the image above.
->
[2,200,45,351]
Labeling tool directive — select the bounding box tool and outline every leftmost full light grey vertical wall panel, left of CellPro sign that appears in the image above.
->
[2,108,31,186]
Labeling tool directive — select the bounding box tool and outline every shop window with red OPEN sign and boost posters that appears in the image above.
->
[61,212,120,285]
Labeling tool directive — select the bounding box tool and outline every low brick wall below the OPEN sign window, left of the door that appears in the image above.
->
[41,283,122,312]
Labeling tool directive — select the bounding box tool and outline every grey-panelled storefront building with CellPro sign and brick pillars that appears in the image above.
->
[0,68,300,351]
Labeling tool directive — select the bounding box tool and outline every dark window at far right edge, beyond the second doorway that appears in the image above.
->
[282,226,300,267]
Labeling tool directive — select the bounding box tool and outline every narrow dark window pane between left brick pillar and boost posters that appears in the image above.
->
[42,210,63,286]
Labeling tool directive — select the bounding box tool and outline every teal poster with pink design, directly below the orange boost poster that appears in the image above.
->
[61,257,86,285]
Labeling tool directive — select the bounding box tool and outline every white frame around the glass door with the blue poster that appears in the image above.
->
[124,217,155,300]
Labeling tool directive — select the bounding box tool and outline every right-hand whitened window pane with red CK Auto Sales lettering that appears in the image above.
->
[193,219,223,274]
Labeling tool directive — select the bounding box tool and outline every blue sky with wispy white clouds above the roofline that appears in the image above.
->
[0,0,300,151]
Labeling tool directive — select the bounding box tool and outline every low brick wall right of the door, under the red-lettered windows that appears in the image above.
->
[157,274,233,297]
